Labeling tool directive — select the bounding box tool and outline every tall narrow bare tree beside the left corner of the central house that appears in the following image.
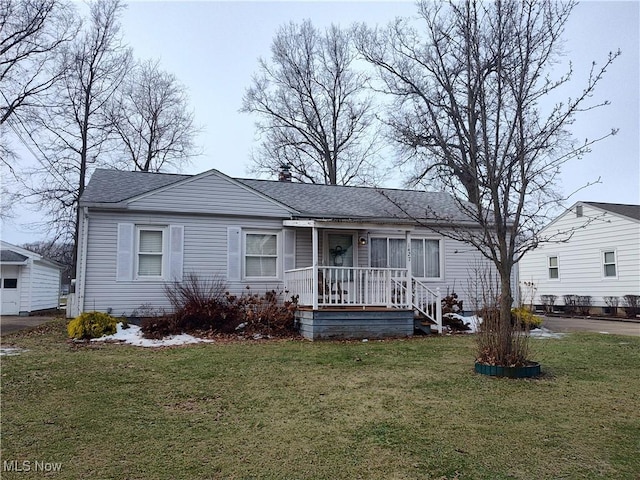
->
[24,0,131,272]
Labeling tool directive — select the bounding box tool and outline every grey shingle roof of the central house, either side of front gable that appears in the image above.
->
[82,169,476,221]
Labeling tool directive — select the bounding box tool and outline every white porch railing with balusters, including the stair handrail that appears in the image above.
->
[284,267,442,333]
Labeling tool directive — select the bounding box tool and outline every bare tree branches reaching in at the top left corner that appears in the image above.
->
[0,0,79,169]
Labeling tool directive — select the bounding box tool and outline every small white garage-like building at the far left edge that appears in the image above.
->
[0,241,62,315]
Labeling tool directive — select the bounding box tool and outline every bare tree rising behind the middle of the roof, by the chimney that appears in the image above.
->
[241,20,378,185]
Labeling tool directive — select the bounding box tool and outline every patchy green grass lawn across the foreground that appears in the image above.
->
[0,322,640,480]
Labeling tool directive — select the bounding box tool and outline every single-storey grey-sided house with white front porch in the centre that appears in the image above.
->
[69,169,498,338]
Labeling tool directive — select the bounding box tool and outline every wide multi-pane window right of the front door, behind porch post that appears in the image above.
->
[370,238,440,278]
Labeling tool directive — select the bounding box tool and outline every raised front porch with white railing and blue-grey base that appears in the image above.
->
[284,266,442,340]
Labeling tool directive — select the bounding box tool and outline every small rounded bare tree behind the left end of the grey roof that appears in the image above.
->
[109,61,197,172]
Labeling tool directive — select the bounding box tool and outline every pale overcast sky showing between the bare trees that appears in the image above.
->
[2,1,640,244]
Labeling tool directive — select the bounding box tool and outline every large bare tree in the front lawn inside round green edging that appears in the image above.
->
[358,0,619,361]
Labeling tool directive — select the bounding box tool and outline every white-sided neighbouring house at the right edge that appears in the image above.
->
[519,202,640,313]
